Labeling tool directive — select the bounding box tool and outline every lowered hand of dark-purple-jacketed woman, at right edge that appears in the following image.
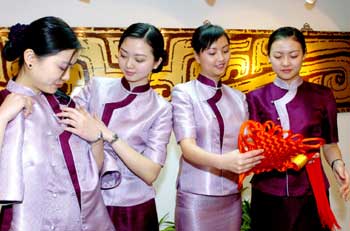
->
[333,161,350,201]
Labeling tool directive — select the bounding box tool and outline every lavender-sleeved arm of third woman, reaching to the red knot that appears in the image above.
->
[172,87,263,173]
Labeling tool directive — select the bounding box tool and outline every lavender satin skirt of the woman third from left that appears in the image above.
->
[175,191,242,231]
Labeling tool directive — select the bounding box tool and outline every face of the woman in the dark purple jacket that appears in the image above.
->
[269,37,304,83]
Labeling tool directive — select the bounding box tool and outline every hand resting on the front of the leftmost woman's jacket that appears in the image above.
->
[56,107,102,142]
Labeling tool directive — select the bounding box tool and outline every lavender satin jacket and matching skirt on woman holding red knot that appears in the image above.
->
[172,75,248,231]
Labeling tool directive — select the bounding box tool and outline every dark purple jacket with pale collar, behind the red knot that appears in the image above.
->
[247,78,338,196]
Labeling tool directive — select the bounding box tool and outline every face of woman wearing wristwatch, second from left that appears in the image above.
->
[118,37,161,87]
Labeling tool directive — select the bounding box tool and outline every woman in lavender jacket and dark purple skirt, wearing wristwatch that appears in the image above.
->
[65,23,172,231]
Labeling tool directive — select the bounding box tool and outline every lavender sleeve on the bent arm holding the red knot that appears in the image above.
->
[171,86,196,142]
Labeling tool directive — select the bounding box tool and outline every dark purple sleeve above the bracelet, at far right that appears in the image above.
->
[322,89,339,143]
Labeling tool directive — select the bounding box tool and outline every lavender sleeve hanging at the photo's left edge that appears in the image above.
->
[0,113,24,204]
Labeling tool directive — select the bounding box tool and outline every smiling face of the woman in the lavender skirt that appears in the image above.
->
[195,35,230,80]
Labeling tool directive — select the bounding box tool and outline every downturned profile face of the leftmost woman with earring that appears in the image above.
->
[27,49,78,94]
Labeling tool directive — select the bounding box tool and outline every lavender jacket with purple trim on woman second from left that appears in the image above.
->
[75,77,172,206]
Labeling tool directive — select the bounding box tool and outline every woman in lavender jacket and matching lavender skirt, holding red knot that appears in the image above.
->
[172,24,262,231]
